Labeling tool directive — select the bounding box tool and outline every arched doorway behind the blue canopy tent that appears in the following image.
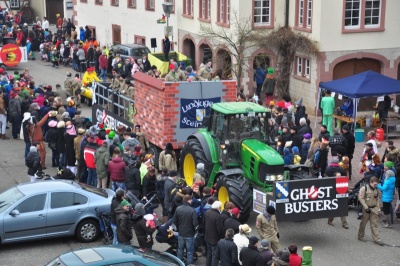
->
[333,58,382,111]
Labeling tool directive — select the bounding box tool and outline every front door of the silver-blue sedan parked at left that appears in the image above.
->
[3,193,47,242]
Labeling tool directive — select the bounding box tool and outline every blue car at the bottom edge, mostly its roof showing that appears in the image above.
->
[46,245,185,266]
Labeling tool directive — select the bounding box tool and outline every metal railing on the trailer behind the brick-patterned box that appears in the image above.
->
[94,82,136,123]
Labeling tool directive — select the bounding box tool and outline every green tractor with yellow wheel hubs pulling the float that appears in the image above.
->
[180,102,284,222]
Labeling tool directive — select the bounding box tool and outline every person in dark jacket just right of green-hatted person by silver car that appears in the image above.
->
[132,203,155,250]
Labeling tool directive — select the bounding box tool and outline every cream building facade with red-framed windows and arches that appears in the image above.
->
[74,0,400,110]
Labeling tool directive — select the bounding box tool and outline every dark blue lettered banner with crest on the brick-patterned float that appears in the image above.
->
[180,97,221,128]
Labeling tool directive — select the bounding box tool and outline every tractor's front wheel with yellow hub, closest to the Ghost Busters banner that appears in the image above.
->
[217,175,253,224]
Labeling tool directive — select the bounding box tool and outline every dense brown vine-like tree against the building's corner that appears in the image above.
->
[253,27,319,97]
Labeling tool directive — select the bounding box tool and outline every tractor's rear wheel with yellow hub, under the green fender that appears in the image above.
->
[180,139,212,186]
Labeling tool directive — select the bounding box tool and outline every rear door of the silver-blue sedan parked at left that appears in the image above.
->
[47,192,89,236]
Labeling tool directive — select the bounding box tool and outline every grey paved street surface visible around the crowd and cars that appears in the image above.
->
[0,61,400,266]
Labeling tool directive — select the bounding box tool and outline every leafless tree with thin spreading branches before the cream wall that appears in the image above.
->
[200,11,259,89]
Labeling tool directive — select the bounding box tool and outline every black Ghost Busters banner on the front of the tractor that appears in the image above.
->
[274,177,349,221]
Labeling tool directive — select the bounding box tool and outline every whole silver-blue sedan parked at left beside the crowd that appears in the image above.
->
[0,180,115,243]
